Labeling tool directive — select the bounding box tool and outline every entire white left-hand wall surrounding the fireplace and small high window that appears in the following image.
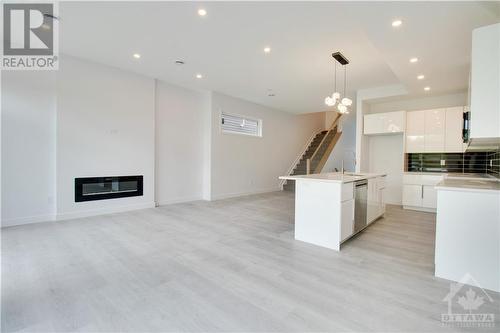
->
[1,56,325,226]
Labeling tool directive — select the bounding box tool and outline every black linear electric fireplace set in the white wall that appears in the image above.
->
[75,176,143,202]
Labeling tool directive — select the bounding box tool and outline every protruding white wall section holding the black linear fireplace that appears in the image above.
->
[56,57,155,219]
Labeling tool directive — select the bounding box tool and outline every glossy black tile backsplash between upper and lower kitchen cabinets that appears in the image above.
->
[405,151,488,177]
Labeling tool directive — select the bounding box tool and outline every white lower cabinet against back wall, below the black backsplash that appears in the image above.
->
[403,174,443,211]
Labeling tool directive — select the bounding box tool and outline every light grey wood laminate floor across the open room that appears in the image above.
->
[1,192,500,332]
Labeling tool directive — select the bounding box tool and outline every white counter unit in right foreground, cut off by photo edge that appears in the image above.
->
[435,176,500,292]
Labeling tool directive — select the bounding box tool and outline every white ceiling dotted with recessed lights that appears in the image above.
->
[59,2,500,113]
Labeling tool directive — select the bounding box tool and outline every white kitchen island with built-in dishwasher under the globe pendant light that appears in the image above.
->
[280,172,385,251]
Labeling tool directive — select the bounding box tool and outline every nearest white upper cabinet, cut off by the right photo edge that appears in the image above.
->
[470,23,500,144]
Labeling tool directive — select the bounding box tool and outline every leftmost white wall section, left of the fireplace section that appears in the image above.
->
[2,71,56,226]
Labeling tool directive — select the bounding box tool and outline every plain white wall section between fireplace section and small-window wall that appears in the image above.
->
[156,81,210,205]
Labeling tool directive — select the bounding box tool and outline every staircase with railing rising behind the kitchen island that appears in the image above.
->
[283,115,342,191]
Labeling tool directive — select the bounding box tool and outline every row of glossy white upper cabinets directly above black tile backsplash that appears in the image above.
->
[406,106,464,153]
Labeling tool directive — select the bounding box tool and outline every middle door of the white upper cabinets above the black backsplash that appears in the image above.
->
[424,109,446,153]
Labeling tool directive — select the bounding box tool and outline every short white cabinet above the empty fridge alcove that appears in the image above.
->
[363,111,406,135]
